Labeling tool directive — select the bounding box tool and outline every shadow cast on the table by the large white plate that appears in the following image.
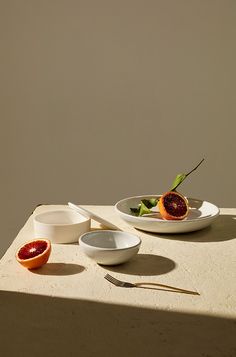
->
[142,214,236,243]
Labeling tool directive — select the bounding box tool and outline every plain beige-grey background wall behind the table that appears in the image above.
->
[0,0,236,254]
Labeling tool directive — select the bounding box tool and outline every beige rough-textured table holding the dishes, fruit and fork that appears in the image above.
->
[0,205,236,357]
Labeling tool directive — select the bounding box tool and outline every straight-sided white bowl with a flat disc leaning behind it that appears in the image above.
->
[33,209,91,243]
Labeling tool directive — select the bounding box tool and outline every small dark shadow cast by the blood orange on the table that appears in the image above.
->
[30,263,85,276]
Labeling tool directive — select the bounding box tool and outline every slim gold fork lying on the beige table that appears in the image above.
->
[104,274,200,295]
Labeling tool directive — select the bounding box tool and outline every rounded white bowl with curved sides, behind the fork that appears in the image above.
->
[79,230,141,265]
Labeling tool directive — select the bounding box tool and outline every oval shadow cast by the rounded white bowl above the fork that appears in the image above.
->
[101,254,176,276]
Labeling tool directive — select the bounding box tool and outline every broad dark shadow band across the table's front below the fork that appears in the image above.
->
[0,291,236,357]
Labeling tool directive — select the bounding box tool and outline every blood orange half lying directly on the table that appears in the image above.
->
[16,239,51,269]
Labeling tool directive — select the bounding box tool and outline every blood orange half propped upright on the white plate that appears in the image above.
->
[159,191,189,220]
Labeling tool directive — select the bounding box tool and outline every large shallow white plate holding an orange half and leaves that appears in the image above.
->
[115,195,220,233]
